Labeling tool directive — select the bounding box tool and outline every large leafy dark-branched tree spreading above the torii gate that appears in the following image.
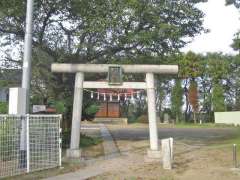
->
[0,0,205,126]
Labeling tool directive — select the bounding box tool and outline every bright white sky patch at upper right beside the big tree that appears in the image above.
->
[183,0,240,54]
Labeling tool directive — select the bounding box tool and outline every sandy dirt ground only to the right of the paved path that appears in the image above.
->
[87,125,240,180]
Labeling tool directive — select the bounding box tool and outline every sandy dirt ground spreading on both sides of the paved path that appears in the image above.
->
[4,124,240,180]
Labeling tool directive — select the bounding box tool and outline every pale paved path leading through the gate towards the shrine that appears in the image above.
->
[43,124,120,180]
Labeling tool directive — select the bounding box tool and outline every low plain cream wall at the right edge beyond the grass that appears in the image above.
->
[214,111,240,125]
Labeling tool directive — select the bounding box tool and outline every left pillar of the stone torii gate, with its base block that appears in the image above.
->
[67,72,84,158]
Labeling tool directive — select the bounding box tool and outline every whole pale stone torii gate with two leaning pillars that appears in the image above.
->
[51,64,178,158]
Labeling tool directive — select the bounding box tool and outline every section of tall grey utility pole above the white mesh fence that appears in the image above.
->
[22,0,34,114]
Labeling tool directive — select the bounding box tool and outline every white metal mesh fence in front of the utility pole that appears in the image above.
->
[0,115,61,178]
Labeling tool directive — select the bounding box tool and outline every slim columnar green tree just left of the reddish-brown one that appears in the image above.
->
[171,79,183,122]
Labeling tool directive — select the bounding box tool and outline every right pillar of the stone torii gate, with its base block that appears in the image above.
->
[146,73,161,159]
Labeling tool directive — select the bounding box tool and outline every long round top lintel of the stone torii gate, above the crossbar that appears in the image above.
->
[51,63,178,74]
